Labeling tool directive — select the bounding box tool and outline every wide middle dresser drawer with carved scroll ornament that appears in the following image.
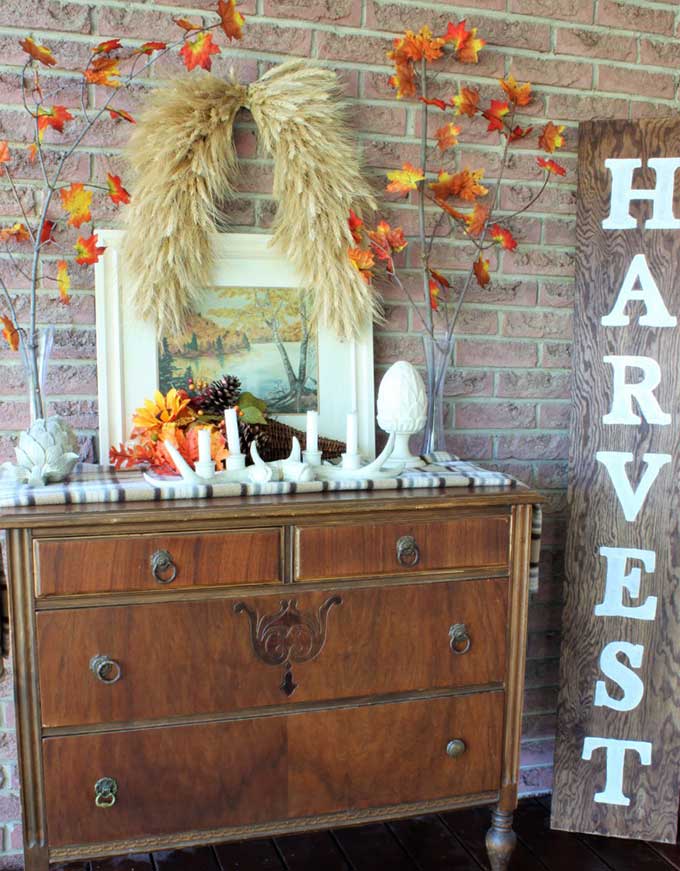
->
[36,579,508,726]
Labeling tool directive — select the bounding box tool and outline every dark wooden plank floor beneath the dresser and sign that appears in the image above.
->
[49,797,680,871]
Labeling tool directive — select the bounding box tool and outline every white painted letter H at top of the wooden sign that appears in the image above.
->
[602,157,680,230]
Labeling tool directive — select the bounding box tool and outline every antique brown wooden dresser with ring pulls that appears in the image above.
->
[0,487,537,871]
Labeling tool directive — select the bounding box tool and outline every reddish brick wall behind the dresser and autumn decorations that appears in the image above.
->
[0,0,680,867]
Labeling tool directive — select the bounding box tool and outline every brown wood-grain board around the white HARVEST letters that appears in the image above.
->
[552,119,680,841]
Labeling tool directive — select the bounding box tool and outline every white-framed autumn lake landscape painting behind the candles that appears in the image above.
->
[95,230,375,457]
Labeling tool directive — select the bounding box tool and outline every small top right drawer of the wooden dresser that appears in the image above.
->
[295,515,510,581]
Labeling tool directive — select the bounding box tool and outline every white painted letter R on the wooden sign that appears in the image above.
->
[602,356,671,426]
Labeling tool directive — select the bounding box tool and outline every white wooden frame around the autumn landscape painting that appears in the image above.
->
[95,229,375,460]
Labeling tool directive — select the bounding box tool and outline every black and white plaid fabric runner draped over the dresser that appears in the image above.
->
[0,452,541,657]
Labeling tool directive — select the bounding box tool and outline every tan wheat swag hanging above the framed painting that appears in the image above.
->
[124,61,380,338]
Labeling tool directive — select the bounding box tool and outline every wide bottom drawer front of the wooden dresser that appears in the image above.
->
[43,692,503,847]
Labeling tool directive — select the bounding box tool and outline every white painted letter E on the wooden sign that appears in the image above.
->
[595,547,657,620]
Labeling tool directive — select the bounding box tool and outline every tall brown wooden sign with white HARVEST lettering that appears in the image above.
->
[552,119,680,841]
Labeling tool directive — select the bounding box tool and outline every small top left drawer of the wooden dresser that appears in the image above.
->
[34,528,283,596]
